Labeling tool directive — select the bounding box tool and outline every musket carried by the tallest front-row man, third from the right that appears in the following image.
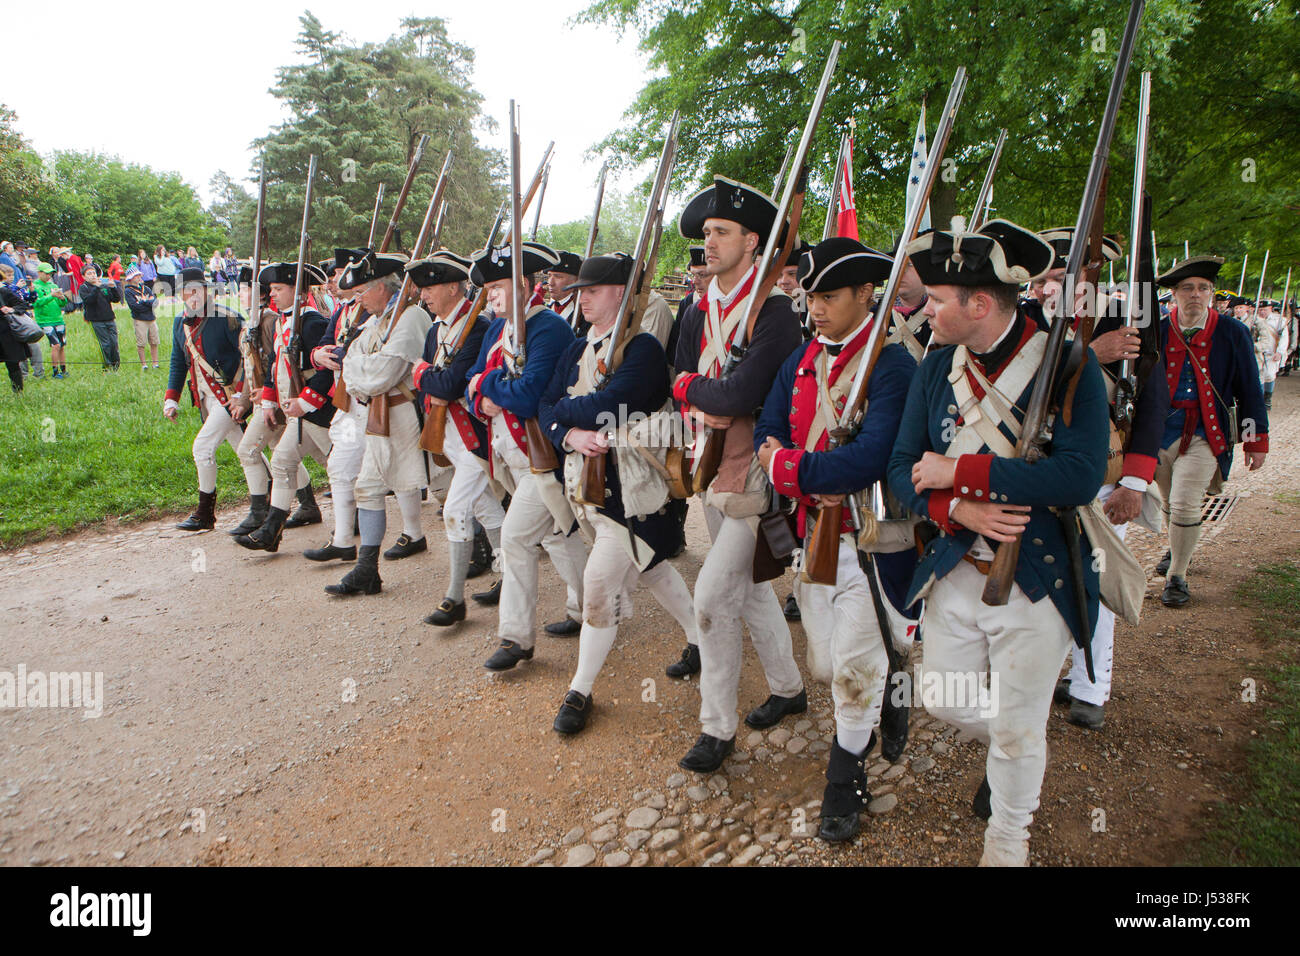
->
[693,40,840,493]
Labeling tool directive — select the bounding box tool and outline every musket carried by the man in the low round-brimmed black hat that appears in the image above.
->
[580,111,681,507]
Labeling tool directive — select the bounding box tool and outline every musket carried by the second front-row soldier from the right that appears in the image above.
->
[802,66,966,584]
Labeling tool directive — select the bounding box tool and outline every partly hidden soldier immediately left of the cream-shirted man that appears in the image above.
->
[303,248,371,561]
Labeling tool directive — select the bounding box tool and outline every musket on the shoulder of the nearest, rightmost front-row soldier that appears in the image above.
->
[983,0,1145,642]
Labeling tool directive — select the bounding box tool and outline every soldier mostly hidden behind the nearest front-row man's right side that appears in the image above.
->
[1026,226,1169,730]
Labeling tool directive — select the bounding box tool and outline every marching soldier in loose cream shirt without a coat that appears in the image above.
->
[325,252,433,597]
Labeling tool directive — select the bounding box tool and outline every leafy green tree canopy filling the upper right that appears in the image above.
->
[580,0,1300,283]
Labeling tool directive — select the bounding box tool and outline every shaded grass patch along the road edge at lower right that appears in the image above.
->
[1191,562,1300,866]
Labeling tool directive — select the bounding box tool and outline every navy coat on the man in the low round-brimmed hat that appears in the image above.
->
[537,332,680,570]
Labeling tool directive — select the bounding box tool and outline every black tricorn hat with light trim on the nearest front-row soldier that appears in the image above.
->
[906,219,1056,286]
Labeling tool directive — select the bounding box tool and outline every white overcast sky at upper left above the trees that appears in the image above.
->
[0,0,644,225]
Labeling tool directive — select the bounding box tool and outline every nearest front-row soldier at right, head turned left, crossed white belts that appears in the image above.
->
[889,220,1108,866]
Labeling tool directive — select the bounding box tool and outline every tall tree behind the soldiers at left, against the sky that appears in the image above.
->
[250,13,503,265]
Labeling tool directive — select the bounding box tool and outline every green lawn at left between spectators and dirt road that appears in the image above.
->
[0,299,321,546]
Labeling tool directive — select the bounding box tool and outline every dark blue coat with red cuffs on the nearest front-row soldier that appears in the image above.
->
[888,332,1110,646]
